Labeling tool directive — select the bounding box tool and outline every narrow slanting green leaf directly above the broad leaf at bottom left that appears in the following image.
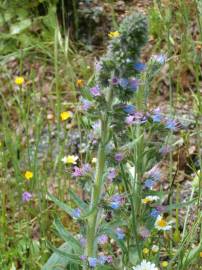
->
[54,218,81,251]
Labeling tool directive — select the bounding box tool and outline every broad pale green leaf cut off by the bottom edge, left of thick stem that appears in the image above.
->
[42,243,79,270]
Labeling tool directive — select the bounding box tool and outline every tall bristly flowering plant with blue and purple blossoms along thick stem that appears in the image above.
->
[43,13,176,270]
